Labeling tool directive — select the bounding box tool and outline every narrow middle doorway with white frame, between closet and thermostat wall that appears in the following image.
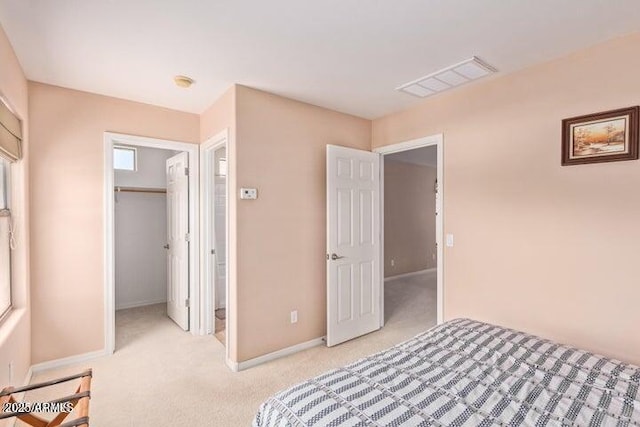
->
[200,130,230,349]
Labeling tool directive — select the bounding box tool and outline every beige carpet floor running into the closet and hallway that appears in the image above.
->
[23,273,436,427]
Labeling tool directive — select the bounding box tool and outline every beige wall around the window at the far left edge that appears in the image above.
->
[0,27,31,385]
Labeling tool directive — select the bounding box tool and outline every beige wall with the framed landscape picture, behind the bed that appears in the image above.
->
[373,33,640,364]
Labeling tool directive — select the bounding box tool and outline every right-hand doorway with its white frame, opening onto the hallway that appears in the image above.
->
[374,134,444,327]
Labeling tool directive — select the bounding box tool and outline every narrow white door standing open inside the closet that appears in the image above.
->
[165,152,189,331]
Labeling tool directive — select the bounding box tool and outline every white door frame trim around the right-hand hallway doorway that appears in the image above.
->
[373,133,444,326]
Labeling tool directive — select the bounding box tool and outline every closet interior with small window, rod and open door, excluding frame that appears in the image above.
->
[113,145,189,349]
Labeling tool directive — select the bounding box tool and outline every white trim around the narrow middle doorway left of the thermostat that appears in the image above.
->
[200,128,231,360]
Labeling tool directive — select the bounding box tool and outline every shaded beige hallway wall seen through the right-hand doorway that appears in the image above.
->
[384,159,436,277]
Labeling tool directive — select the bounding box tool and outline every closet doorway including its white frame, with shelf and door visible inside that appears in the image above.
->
[104,132,200,354]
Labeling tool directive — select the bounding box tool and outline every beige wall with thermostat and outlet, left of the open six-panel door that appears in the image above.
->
[230,86,371,361]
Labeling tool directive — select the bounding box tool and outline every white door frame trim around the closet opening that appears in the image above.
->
[103,132,201,354]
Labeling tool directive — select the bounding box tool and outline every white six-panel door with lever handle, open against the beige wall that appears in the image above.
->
[327,145,382,346]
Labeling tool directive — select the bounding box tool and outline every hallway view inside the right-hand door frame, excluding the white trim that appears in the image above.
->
[382,145,438,327]
